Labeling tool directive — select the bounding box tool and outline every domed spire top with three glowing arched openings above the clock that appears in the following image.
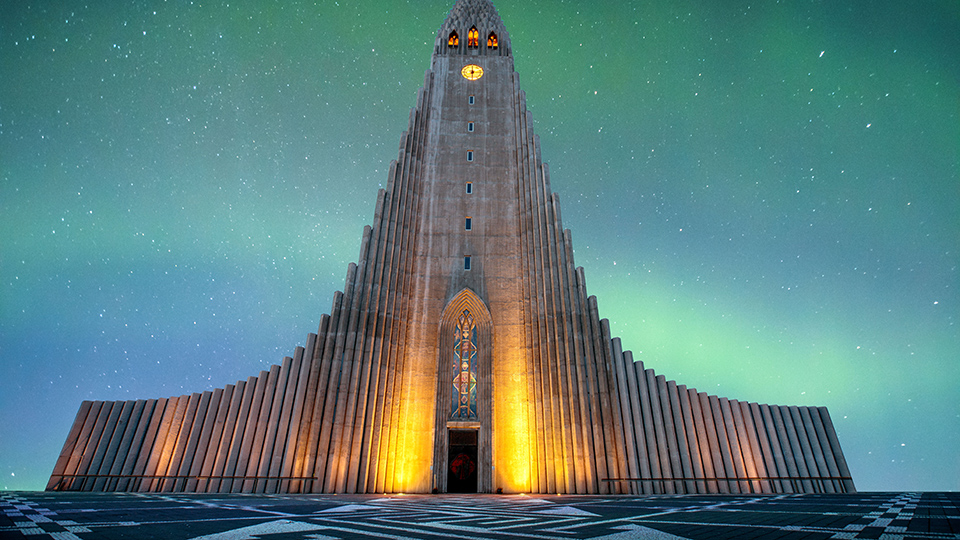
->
[434,0,510,56]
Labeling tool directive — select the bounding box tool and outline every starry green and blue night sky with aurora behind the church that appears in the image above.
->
[0,0,960,490]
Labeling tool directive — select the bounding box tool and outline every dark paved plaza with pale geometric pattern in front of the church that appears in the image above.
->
[0,492,960,540]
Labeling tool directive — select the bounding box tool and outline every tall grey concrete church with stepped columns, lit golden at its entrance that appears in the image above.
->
[47,0,855,494]
